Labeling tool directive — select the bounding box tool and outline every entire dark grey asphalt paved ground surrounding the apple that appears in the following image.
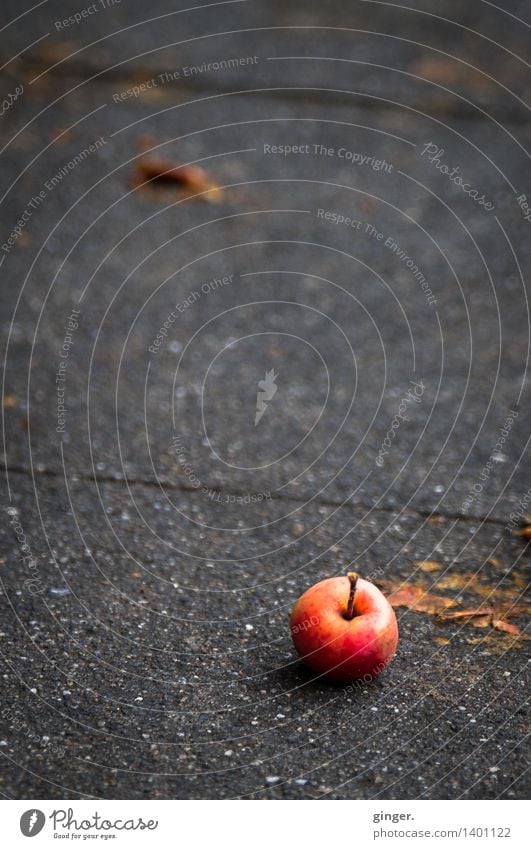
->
[0,0,531,799]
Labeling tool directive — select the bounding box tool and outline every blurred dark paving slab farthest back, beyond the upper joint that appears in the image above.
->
[0,0,531,121]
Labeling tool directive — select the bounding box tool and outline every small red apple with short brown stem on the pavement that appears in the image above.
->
[290,572,398,683]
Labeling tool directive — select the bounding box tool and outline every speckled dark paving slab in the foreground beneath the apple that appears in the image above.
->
[0,475,528,799]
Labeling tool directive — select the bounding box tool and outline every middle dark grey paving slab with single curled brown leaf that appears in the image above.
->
[1,79,529,518]
